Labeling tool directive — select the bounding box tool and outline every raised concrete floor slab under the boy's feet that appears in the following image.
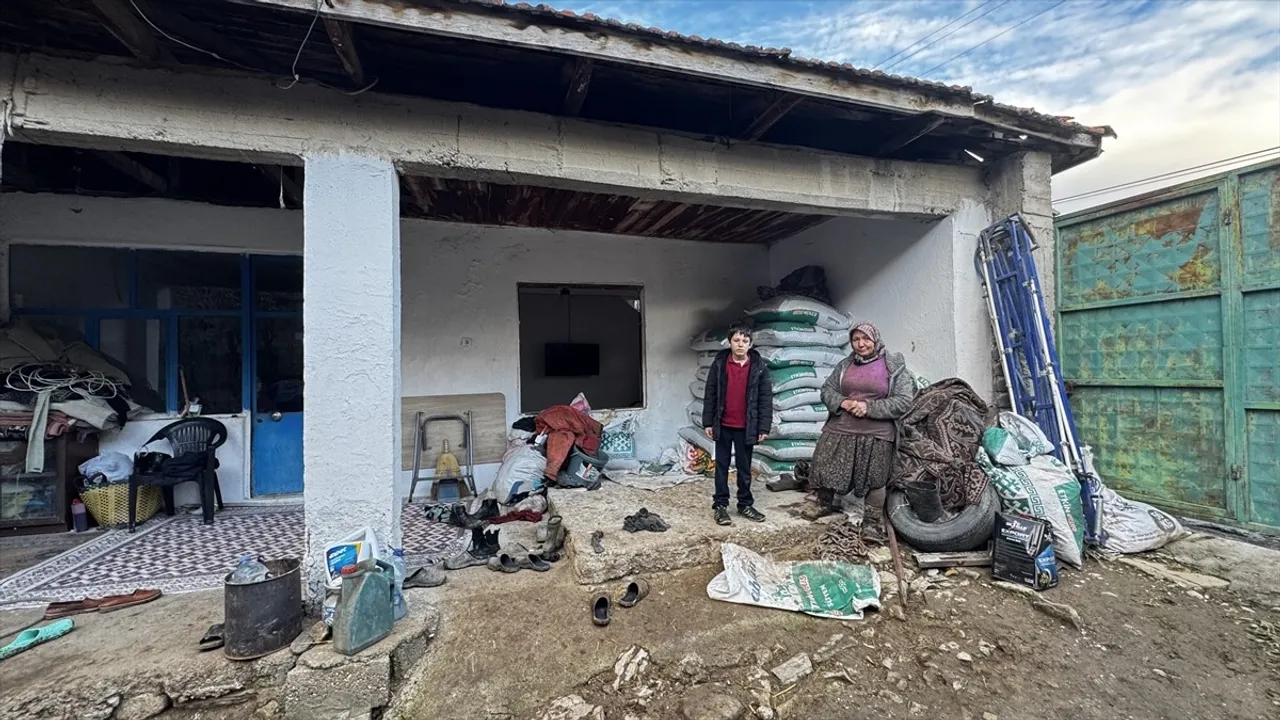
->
[549,478,827,584]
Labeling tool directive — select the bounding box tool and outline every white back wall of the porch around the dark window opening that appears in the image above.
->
[0,193,769,502]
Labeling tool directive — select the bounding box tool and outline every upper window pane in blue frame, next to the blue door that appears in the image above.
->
[138,250,241,310]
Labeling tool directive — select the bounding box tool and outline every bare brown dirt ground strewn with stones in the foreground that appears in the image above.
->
[393,543,1280,720]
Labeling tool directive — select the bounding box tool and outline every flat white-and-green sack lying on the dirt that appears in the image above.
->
[707,542,879,620]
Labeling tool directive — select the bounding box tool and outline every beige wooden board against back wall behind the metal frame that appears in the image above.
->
[401,392,507,475]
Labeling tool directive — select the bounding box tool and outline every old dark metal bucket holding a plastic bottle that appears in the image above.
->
[223,557,302,660]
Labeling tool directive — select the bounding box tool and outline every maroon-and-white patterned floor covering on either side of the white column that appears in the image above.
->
[0,505,470,609]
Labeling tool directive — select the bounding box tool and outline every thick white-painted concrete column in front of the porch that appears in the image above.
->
[302,155,401,606]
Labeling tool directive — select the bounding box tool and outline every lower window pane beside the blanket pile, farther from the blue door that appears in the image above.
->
[99,319,169,413]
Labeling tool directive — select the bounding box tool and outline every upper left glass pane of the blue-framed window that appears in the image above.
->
[9,245,129,310]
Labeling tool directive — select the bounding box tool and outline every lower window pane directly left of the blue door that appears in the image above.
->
[178,316,244,415]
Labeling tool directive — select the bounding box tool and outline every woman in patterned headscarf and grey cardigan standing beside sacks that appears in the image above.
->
[804,323,915,542]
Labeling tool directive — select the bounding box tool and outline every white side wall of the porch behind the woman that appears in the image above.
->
[769,205,991,397]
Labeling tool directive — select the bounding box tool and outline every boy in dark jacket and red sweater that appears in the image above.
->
[703,325,773,525]
